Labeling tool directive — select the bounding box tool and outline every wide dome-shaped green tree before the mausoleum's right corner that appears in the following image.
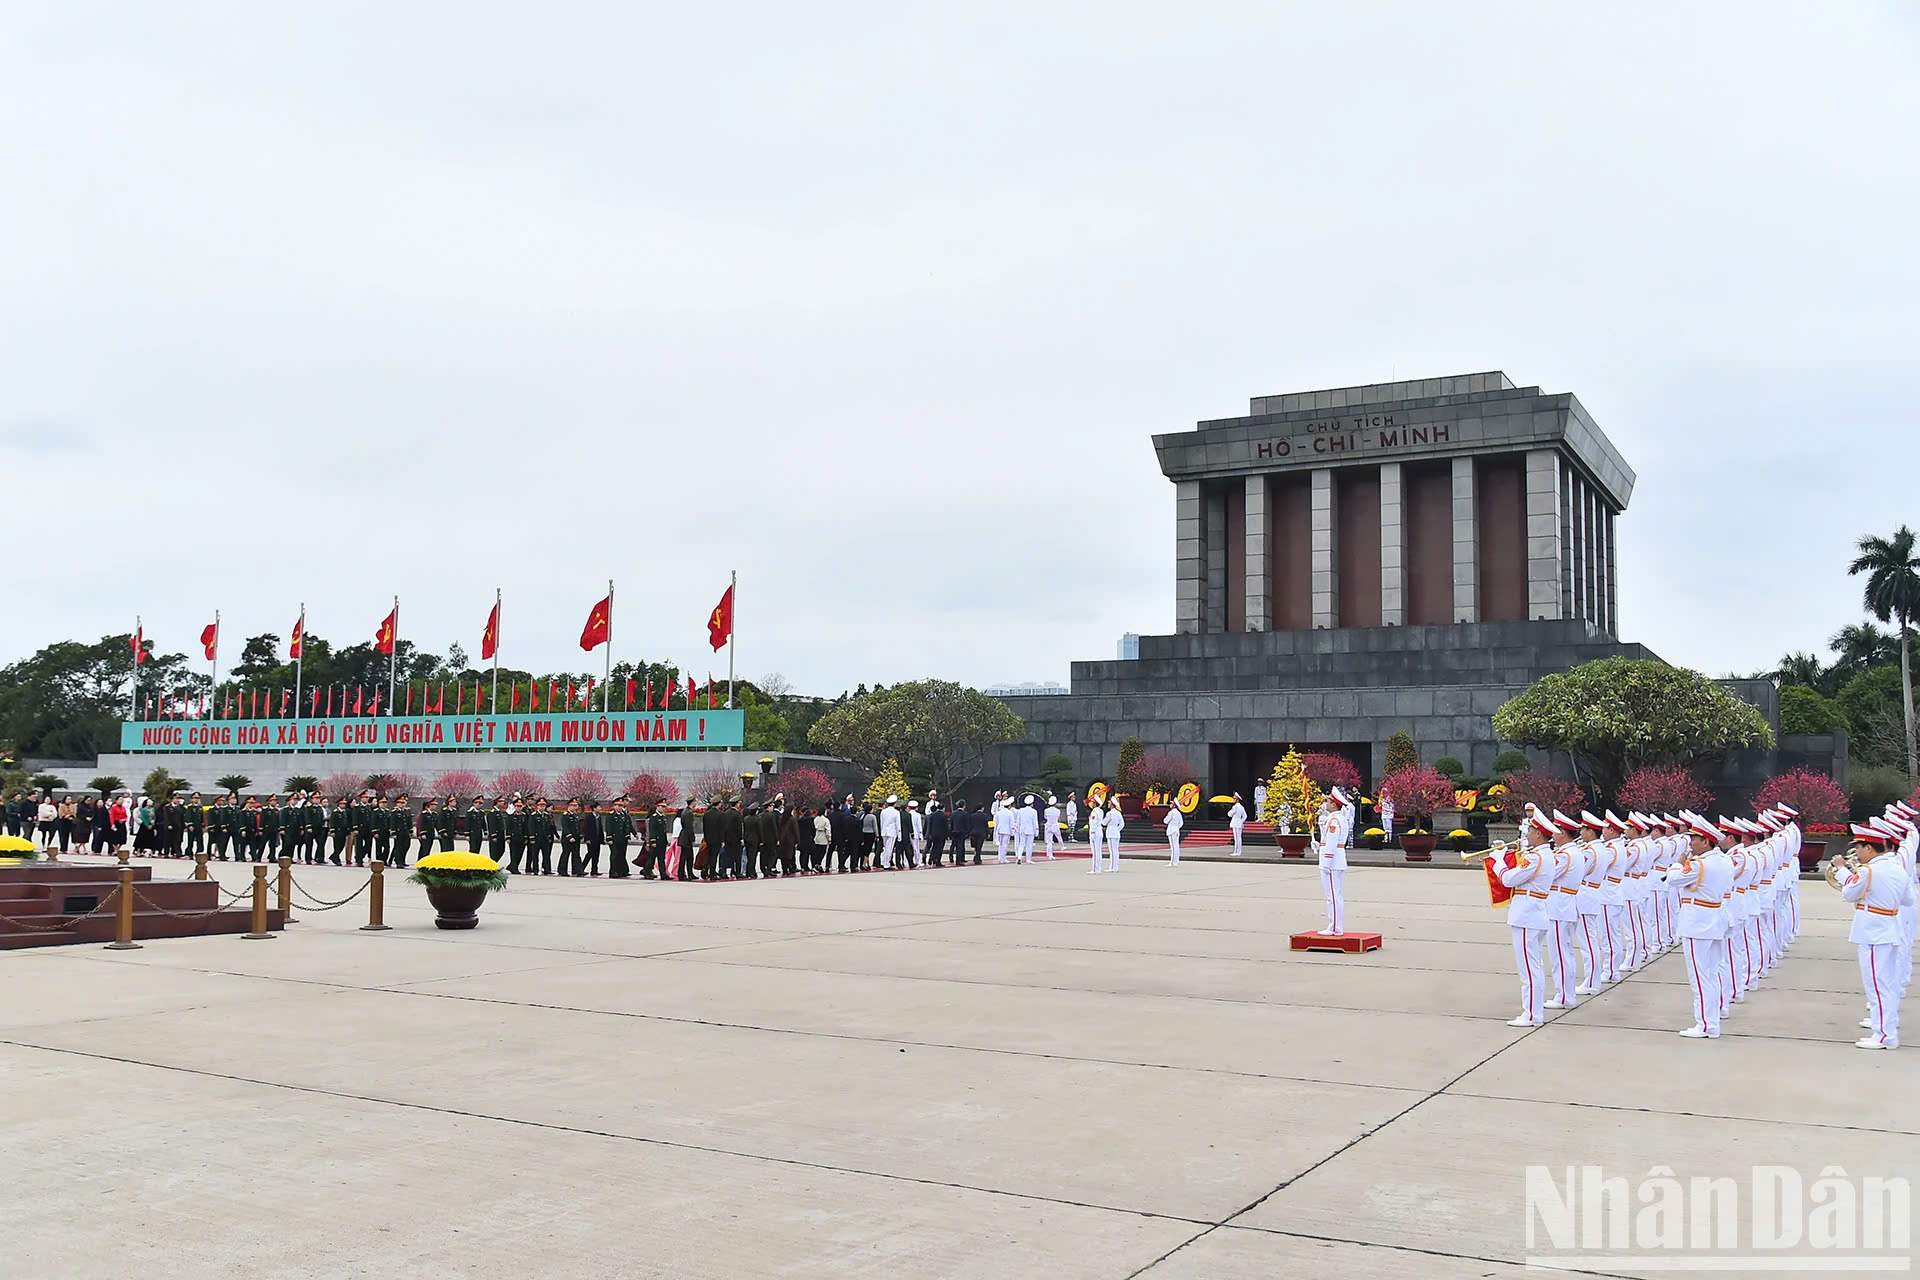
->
[1494,658,1774,794]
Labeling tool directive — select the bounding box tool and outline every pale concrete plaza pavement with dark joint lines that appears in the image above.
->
[0,844,1920,1280]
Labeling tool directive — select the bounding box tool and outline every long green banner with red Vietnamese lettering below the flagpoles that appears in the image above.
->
[121,710,747,752]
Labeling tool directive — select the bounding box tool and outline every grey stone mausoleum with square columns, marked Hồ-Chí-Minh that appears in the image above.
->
[987,372,1804,794]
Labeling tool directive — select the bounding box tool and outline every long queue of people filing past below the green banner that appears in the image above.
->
[4,791,1119,881]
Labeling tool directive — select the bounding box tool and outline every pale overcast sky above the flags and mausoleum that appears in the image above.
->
[0,0,1920,693]
